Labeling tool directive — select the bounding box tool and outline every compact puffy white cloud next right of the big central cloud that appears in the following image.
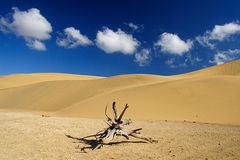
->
[154,32,193,56]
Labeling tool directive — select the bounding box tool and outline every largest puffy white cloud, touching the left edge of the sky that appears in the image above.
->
[0,7,52,50]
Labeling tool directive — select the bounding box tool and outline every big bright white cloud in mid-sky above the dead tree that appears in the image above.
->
[96,28,140,55]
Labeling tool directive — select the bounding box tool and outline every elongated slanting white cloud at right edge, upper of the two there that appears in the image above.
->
[196,22,240,49]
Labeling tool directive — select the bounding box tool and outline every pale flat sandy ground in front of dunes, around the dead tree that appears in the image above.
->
[0,112,240,160]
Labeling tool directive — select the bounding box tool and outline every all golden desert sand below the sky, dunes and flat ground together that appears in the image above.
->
[0,60,240,160]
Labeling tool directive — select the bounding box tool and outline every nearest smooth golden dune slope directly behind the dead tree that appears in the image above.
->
[56,77,240,124]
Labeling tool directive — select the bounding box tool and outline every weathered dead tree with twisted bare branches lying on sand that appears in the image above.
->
[81,102,157,152]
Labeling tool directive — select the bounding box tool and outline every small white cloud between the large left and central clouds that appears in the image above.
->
[56,27,92,48]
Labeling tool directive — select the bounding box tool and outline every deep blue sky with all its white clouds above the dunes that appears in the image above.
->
[0,0,240,76]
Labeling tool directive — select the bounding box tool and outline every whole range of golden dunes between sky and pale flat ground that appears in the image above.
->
[0,60,240,125]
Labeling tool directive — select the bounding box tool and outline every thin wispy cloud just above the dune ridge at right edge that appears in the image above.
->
[209,49,240,65]
